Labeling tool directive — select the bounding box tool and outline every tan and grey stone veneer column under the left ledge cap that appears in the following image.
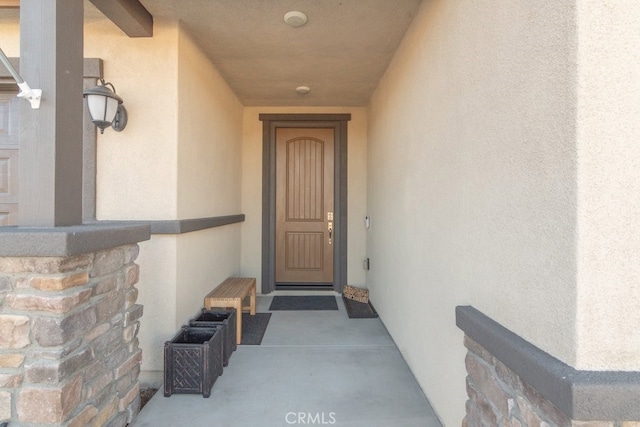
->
[0,244,142,427]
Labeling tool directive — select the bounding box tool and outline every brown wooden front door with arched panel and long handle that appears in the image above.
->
[275,128,334,286]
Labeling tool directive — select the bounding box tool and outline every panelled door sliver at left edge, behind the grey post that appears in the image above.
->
[0,92,20,226]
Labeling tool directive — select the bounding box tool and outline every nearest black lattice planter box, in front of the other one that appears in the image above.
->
[164,326,223,397]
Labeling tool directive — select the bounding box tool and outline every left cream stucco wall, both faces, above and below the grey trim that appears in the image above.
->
[85,17,243,381]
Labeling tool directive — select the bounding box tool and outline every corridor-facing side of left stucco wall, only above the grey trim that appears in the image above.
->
[177,29,243,218]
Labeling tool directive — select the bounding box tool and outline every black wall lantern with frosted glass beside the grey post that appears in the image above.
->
[83,79,127,133]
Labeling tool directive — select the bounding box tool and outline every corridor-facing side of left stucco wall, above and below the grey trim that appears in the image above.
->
[175,28,243,327]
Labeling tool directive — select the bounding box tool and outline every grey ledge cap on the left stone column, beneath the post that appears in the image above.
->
[0,222,151,257]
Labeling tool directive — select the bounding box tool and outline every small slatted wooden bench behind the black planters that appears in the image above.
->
[204,277,256,344]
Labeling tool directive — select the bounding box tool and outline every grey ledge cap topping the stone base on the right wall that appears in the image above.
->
[456,306,640,421]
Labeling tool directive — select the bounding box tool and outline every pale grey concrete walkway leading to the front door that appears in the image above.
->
[132,293,441,427]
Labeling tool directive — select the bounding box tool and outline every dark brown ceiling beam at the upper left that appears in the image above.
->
[87,0,153,37]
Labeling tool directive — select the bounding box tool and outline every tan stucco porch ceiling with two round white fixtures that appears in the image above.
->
[134,0,422,106]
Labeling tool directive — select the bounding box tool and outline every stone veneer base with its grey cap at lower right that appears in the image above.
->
[456,306,640,427]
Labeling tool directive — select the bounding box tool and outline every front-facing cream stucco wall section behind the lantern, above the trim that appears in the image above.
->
[84,19,178,220]
